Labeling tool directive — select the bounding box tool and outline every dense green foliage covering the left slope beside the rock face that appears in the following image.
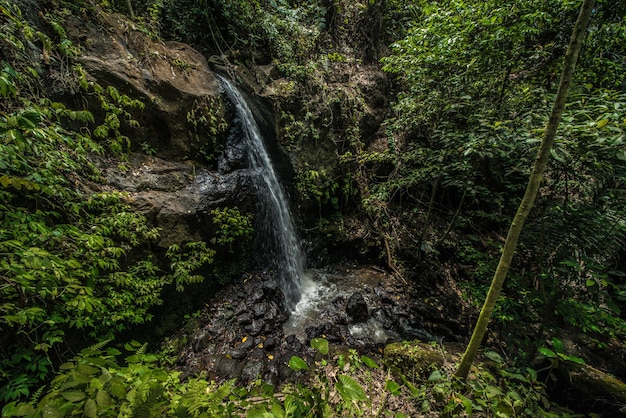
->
[0,1,244,403]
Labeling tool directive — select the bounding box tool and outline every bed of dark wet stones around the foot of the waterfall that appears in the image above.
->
[176,268,466,384]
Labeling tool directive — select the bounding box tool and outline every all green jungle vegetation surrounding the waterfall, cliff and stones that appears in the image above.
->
[0,0,626,417]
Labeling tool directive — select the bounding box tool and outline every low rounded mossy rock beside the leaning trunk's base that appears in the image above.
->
[384,341,444,381]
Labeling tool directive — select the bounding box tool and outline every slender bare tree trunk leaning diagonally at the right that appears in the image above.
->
[454,0,595,380]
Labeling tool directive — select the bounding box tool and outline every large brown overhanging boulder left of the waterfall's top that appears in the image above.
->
[65,13,228,161]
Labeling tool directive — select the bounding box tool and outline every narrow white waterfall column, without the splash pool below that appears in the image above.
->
[217,75,304,310]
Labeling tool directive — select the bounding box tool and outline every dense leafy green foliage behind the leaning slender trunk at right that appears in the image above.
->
[370,1,626,346]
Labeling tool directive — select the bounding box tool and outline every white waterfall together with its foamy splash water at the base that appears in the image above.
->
[218,75,398,342]
